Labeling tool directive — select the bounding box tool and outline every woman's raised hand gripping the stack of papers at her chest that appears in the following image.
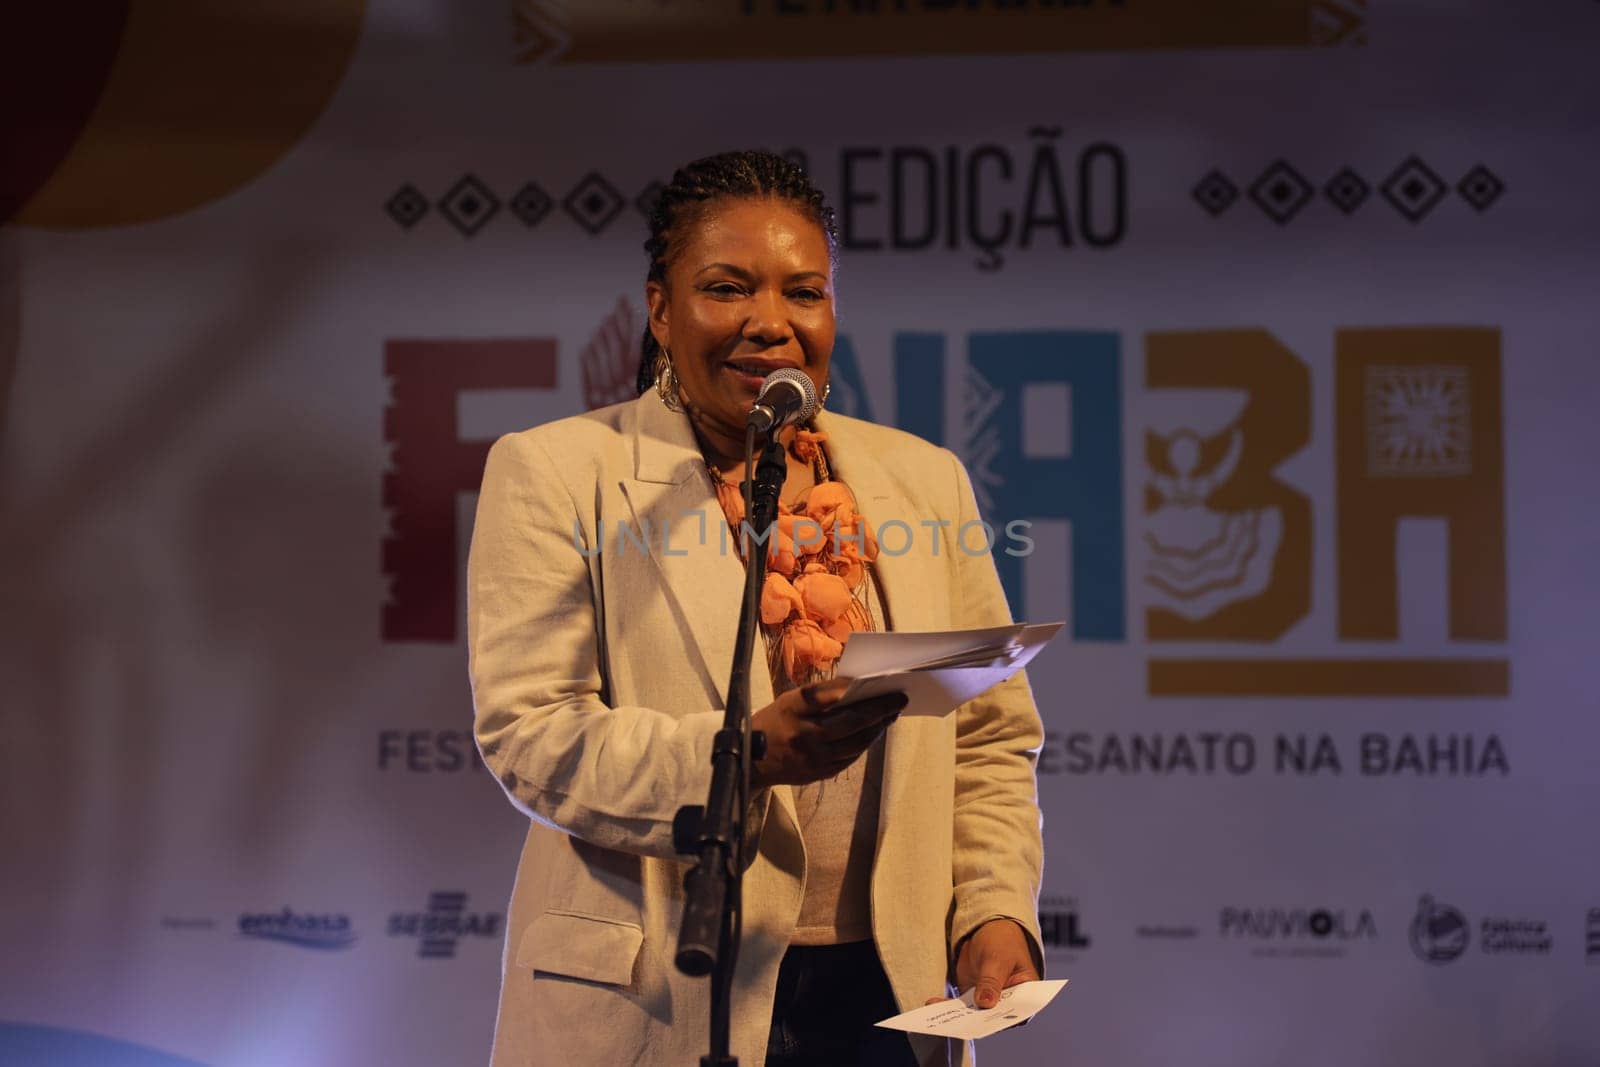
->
[750,678,906,787]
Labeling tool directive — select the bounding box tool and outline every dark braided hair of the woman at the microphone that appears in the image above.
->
[635,152,838,392]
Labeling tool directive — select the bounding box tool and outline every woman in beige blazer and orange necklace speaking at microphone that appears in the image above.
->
[469,152,1043,1067]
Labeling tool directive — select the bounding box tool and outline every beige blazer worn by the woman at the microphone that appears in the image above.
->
[469,394,1043,1067]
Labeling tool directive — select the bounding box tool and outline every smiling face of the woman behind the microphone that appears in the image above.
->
[645,198,834,440]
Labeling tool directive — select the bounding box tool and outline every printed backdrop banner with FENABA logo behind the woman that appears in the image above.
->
[0,0,1600,1067]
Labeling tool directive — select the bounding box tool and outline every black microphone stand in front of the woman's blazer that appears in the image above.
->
[672,426,789,1067]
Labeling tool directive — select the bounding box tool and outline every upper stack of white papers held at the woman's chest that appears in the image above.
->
[837,622,1062,715]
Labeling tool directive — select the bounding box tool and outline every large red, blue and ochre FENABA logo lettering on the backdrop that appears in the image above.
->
[382,321,1510,697]
